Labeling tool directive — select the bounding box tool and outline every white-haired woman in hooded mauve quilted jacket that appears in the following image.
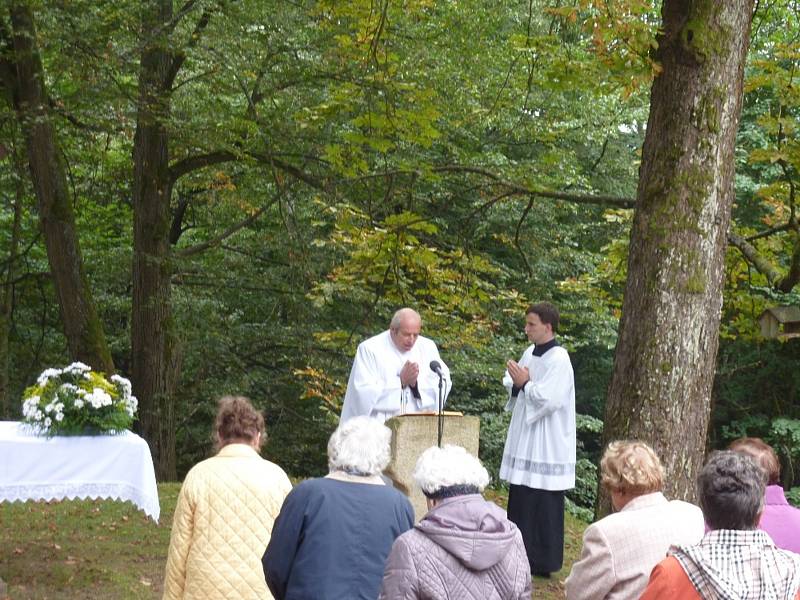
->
[380,445,531,600]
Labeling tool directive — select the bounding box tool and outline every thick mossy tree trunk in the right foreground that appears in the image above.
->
[598,0,753,514]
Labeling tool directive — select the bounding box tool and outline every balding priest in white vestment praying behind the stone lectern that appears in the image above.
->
[339,308,451,423]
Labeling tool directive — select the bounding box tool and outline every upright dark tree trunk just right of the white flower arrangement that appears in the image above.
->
[131,0,180,480]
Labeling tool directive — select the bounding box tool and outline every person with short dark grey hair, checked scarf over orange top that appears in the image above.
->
[642,450,800,600]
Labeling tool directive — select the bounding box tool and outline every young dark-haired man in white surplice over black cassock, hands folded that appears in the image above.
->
[500,302,576,577]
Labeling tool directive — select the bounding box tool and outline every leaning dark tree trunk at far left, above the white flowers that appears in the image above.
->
[5,2,114,373]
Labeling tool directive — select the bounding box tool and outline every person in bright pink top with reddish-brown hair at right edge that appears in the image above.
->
[728,437,800,554]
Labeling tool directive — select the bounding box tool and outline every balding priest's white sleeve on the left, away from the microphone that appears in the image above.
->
[340,343,403,423]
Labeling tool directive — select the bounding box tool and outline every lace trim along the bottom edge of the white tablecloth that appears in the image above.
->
[0,483,161,523]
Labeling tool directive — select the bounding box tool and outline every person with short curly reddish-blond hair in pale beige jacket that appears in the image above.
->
[565,441,703,600]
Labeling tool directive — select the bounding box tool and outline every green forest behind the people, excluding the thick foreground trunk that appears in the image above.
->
[0,0,800,516]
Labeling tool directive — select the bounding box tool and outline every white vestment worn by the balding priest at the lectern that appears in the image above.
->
[340,330,451,423]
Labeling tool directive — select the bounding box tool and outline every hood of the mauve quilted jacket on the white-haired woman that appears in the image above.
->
[416,494,517,571]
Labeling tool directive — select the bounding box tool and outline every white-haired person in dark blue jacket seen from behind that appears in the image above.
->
[262,416,414,600]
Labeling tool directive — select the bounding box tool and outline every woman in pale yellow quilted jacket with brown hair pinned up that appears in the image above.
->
[164,396,292,600]
